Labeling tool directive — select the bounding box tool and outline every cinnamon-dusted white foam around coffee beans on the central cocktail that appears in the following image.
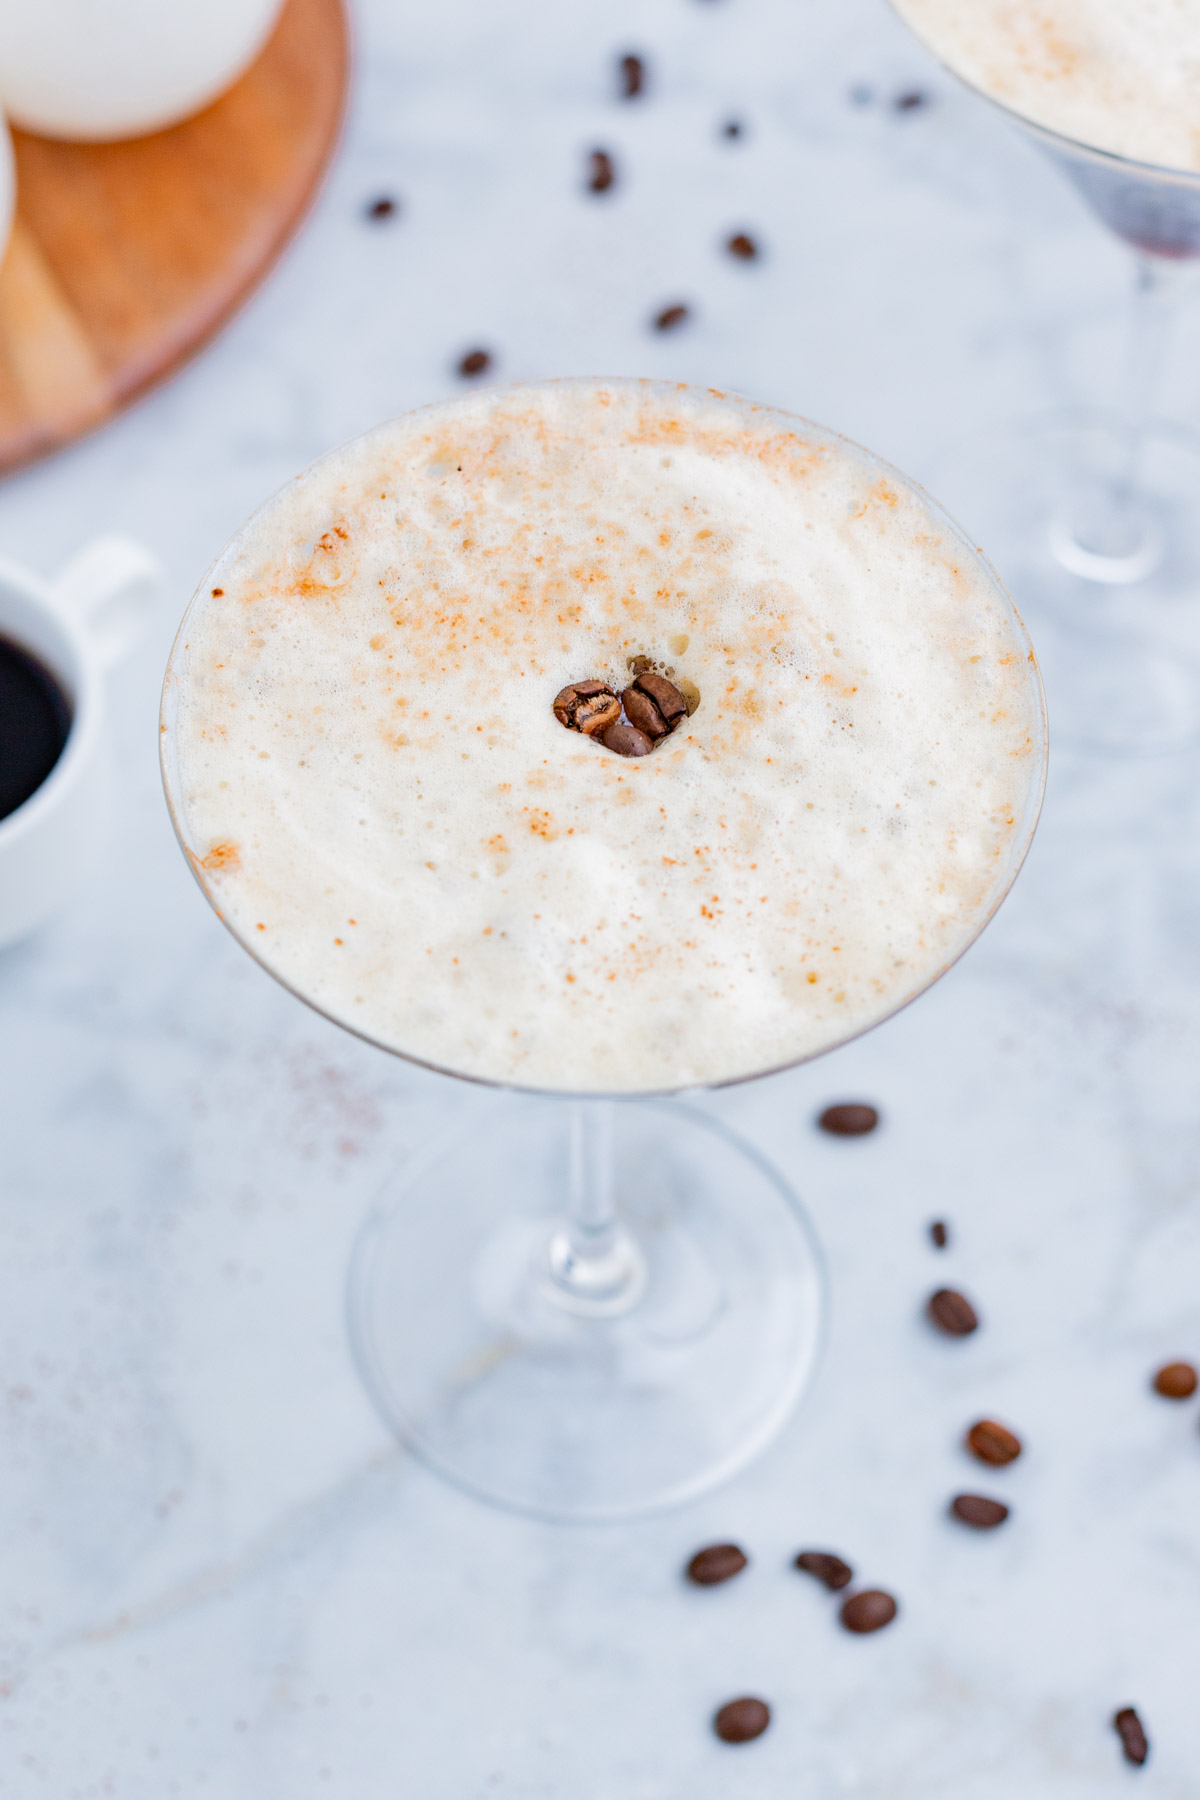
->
[164,382,1042,1093]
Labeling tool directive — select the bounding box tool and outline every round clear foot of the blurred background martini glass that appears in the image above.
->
[928,416,1200,754]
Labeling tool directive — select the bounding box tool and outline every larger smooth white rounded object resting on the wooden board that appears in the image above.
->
[0,0,282,140]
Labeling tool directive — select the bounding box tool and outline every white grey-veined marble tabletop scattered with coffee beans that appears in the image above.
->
[0,0,1200,1800]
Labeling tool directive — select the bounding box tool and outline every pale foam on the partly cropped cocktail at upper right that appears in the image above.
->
[892,0,1200,169]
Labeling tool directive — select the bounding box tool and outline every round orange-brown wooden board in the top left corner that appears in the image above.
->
[0,0,349,472]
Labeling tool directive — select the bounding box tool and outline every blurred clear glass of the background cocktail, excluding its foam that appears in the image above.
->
[892,8,1200,754]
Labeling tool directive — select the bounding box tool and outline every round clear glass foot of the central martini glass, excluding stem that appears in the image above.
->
[349,1098,824,1519]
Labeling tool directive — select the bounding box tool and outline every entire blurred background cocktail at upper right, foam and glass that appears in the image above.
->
[892,0,1200,752]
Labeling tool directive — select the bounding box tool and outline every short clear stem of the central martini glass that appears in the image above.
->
[551,1100,646,1314]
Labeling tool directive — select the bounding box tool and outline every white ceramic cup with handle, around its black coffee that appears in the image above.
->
[0,536,162,947]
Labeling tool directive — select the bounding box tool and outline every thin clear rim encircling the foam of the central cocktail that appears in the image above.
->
[158,376,1049,1100]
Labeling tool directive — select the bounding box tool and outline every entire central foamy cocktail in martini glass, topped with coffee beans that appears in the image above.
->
[162,380,1045,1519]
